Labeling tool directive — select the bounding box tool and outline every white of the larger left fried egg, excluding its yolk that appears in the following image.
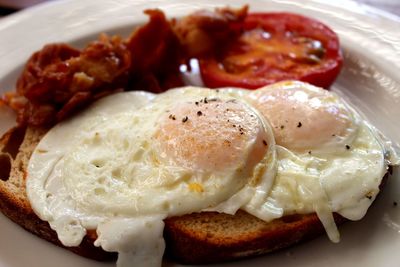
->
[27,87,276,266]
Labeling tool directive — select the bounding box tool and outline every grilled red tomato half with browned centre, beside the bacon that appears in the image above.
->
[199,13,343,89]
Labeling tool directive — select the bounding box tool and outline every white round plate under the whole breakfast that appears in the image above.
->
[0,0,400,267]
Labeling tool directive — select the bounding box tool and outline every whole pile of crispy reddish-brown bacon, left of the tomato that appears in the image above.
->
[2,6,247,125]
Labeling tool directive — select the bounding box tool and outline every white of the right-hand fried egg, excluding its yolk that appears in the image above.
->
[219,81,398,242]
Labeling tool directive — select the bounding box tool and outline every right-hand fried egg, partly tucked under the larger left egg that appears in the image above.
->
[241,81,395,242]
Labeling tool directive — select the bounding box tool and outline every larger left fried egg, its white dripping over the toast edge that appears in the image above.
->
[27,87,276,266]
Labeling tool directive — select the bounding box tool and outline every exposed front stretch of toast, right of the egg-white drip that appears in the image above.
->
[164,211,346,264]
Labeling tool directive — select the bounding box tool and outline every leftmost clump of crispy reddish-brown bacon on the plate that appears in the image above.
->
[9,35,131,125]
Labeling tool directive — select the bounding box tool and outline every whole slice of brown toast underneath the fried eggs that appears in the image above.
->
[0,126,354,264]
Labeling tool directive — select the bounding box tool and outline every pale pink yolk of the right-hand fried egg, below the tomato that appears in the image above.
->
[250,82,354,151]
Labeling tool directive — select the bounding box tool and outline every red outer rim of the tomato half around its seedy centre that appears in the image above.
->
[199,12,343,89]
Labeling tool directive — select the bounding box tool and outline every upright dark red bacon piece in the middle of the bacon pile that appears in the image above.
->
[127,9,183,93]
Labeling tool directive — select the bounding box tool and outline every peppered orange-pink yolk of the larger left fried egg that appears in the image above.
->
[155,98,272,171]
